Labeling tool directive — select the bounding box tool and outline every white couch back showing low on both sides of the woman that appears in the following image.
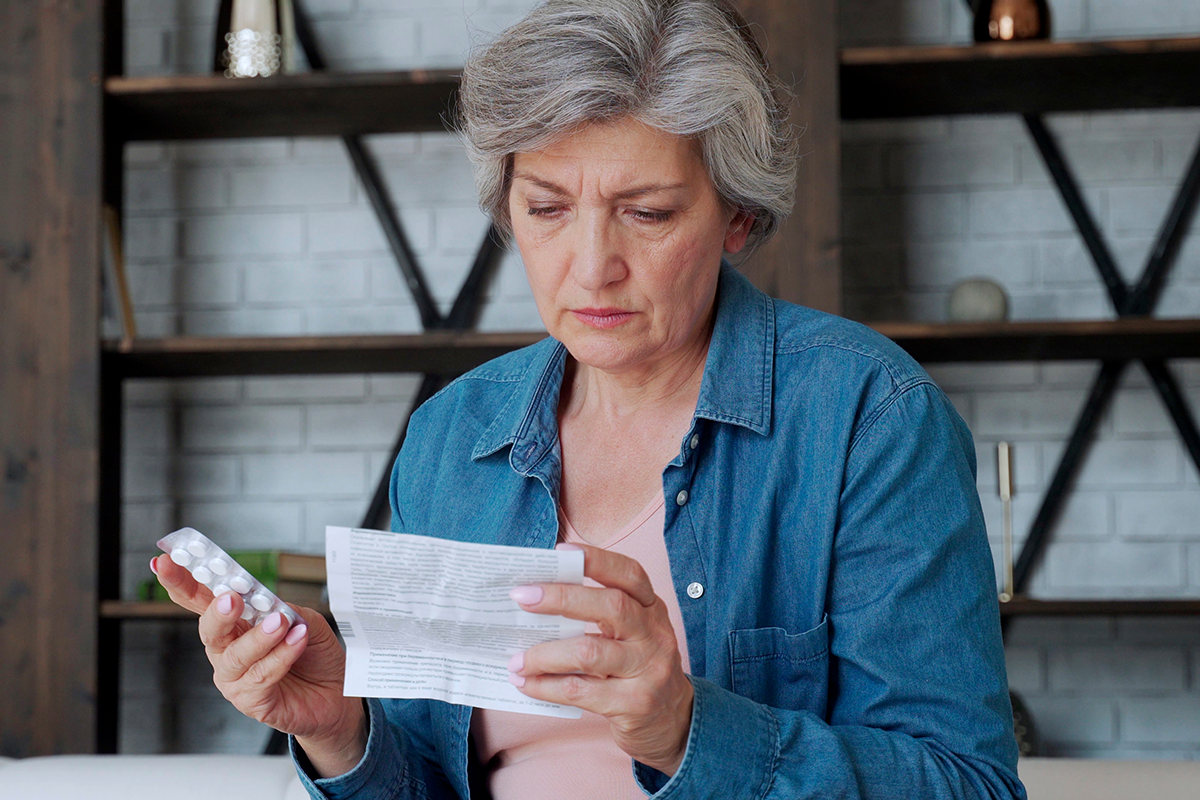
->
[0,756,1200,800]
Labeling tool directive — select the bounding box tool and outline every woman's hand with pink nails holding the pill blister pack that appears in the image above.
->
[151,558,367,777]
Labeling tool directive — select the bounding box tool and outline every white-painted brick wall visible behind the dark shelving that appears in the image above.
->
[121,0,1200,758]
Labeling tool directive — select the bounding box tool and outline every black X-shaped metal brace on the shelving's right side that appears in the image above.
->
[1013,114,1200,591]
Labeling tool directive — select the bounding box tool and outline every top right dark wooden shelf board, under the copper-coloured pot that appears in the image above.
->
[841,37,1200,120]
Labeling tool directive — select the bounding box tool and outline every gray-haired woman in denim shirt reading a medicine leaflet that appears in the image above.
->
[158,0,1024,799]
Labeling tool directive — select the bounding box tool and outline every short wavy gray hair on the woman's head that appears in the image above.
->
[458,0,798,253]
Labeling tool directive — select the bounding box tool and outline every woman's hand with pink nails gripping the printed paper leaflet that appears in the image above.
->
[509,546,692,775]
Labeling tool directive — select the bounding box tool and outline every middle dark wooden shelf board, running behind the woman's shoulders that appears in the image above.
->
[102,319,1200,378]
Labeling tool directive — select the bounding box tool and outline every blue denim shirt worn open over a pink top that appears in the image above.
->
[293,265,1025,800]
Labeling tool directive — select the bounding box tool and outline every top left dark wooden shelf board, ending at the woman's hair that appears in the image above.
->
[104,70,458,142]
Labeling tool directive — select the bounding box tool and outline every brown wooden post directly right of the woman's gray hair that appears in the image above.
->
[739,0,841,313]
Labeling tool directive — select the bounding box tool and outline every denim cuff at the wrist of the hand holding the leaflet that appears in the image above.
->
[634,675,780,800]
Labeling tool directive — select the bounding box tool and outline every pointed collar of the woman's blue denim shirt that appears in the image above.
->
[472,261,775,474]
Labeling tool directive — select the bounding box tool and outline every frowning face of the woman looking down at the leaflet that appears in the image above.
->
[509,119,750,373]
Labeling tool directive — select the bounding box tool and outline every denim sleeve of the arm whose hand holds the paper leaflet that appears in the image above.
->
[634,380,1025,800]
